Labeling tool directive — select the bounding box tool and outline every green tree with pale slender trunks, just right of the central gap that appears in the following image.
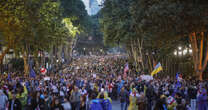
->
[100,0,150,70]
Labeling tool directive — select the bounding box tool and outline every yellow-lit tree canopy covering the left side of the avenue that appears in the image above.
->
[0,0,91,74]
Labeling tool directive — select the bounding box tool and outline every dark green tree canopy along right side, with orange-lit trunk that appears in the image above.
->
[100,0,208,79]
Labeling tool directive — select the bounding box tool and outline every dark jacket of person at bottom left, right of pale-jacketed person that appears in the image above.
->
[9,99,22,110]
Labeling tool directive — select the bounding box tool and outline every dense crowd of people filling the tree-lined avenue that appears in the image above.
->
[0,57,208,110]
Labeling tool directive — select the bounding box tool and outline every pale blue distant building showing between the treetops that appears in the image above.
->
[82,0,104,15]
